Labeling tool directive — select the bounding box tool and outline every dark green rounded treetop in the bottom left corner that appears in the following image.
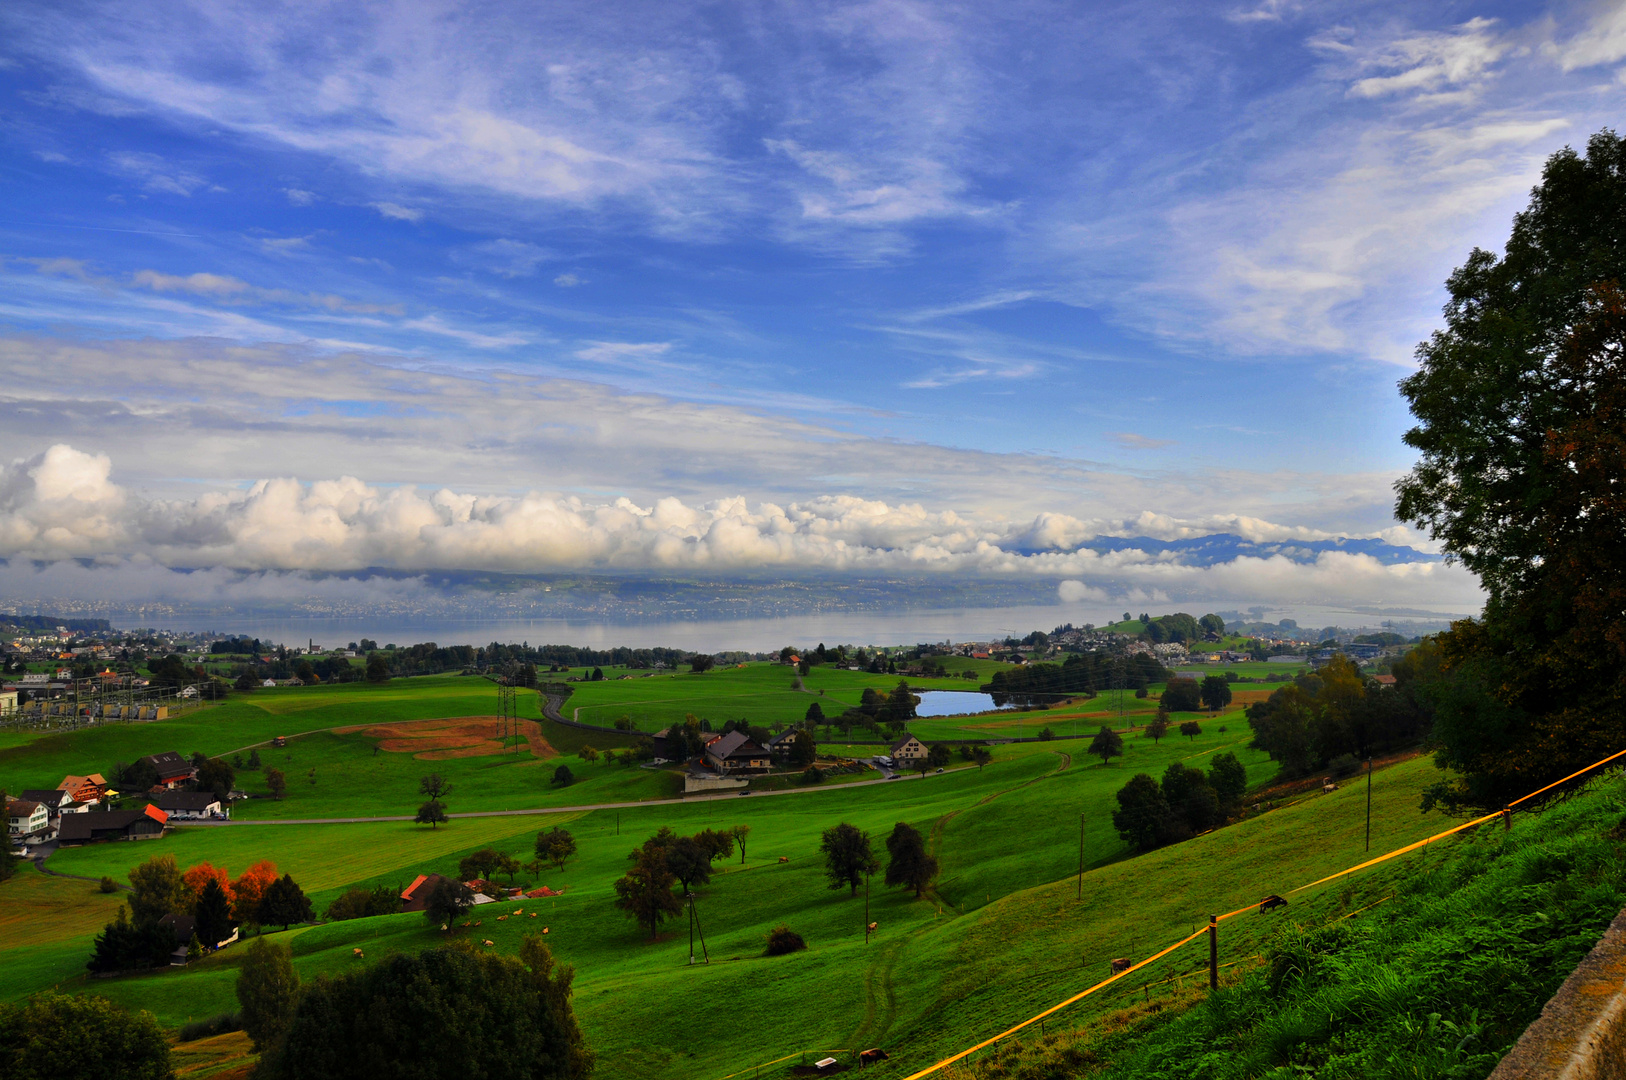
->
[0,991,174,1080]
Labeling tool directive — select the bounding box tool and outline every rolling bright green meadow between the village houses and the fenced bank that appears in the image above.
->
[0,665,1580,1080]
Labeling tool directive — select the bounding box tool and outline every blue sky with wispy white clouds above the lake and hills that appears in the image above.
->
[0,2,1626,608]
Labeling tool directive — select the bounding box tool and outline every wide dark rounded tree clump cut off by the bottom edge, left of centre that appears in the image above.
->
[257,937,592,1080]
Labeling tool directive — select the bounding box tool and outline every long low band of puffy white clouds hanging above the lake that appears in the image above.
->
[0,444,1476,610]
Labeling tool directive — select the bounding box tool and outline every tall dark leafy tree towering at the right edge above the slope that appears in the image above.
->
[1395,130,1626,807]
